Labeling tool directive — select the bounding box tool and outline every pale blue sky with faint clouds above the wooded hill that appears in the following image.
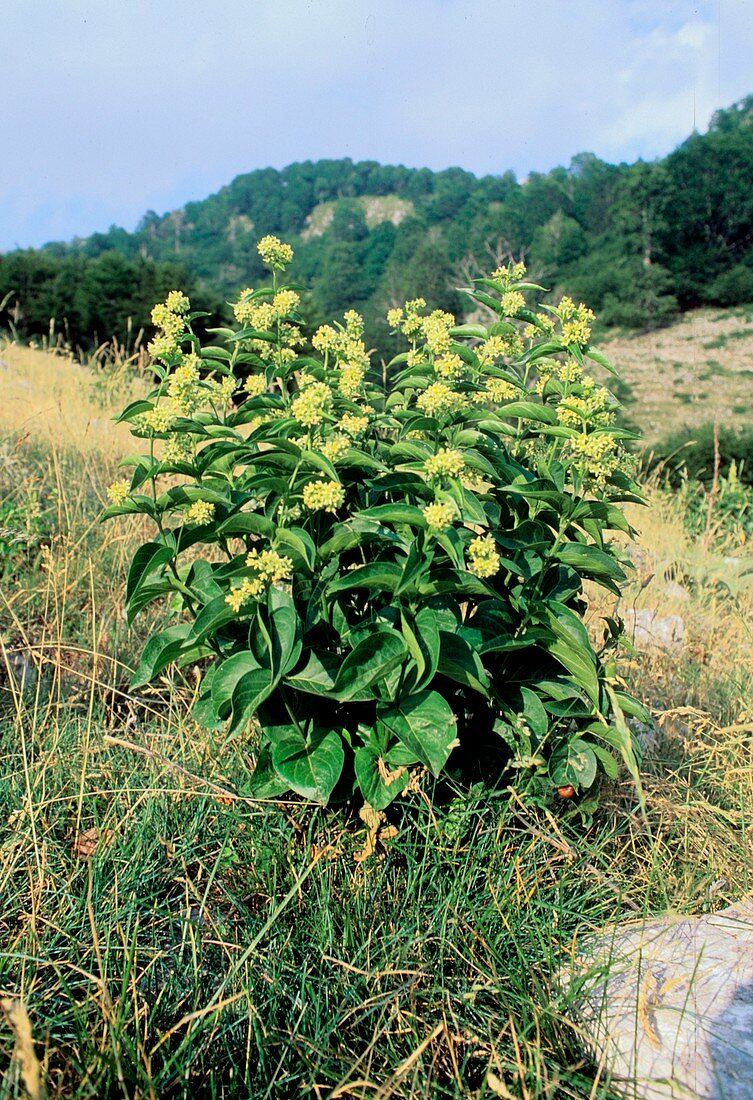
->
[0,0,753,250]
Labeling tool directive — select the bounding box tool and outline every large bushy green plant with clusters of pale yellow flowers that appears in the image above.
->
[106,238,640,809]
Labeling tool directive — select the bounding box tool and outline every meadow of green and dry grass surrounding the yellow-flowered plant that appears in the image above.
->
[0,327,753,1100]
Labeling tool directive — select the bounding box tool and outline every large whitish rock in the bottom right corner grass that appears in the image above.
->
[560,900,753,1100]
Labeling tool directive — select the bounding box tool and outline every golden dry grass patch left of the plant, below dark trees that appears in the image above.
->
[0,343,145,459]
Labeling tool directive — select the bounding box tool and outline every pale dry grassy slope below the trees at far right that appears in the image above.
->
[599,306,753,444]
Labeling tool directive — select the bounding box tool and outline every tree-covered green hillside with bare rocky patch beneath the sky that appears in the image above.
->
[0,96,753,347]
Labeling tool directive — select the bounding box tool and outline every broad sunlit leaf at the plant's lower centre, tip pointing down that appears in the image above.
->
[377,691,458,776]
